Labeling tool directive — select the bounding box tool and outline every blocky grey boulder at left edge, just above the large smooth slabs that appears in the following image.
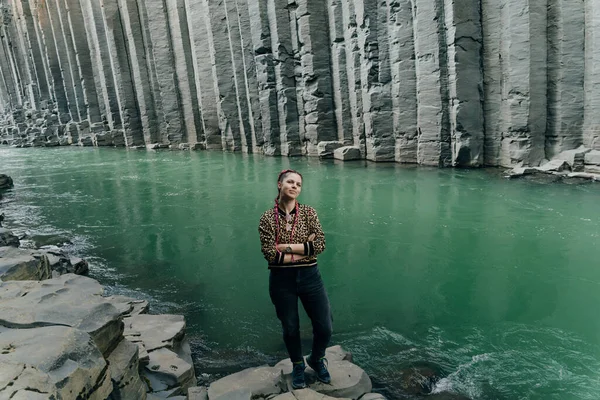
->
[0,247,52,280]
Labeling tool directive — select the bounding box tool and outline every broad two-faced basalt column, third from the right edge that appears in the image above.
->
[500,0,548,167]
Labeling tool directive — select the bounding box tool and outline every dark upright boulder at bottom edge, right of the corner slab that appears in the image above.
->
[108,339,146,400]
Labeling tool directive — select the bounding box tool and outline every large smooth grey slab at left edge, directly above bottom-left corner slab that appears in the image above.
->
[0,274,123,356]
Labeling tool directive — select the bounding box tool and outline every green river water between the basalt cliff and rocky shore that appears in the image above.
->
[0,148,600,399]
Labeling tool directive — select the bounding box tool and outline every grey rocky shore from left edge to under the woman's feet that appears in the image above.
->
[0,175,385,400]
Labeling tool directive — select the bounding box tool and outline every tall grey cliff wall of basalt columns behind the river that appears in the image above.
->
[0,0,600,166]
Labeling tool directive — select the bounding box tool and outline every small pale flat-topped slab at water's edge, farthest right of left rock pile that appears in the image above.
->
[123,314,185,352]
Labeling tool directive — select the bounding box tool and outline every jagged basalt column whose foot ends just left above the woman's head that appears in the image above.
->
[248,0,281,155]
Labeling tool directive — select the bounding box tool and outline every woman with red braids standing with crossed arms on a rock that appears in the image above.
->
[258,169,332,389]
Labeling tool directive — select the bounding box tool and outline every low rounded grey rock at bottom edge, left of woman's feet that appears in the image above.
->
[208,366,283,400]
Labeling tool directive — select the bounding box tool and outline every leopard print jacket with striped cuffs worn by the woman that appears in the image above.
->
[258,204,325,268]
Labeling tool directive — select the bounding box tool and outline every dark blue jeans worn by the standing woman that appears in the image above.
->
[269,267,332,362]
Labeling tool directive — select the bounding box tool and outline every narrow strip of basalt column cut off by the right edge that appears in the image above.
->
[583,0,600,150]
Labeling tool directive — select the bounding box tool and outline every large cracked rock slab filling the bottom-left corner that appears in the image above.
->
[0,326,113,400]
